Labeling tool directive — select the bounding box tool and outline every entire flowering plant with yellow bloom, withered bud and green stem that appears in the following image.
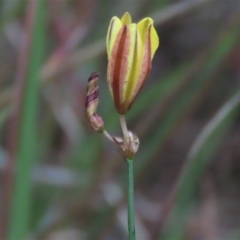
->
[86,12,159,240]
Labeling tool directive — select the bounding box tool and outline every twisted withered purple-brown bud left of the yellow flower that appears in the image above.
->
[86,72,104,132]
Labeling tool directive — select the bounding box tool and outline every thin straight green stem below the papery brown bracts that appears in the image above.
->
[127,159,135,240]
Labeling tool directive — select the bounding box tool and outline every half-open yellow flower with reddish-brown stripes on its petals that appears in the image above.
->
[106,13,159,115]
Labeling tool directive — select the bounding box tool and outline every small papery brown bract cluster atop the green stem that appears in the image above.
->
[113,131,140,159]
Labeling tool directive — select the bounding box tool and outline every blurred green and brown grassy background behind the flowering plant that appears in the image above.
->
[0,0,240,240]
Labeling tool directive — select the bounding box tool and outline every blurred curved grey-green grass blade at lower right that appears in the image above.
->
[161,90,240,240]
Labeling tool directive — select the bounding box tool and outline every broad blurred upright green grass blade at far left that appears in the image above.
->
[8,0,45,240]
